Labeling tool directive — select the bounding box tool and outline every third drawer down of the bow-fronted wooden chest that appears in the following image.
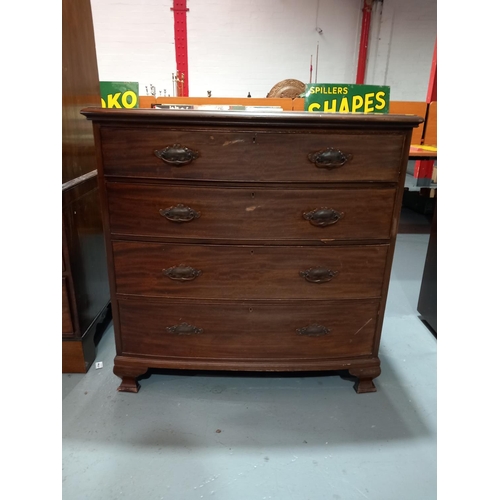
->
[113,241,388,299]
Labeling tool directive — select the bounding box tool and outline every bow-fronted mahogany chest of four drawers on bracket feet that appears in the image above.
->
[82,108,422,393]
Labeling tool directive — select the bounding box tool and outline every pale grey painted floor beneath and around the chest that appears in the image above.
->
[62,228,437,500]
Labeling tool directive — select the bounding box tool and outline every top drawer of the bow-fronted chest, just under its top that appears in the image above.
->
[101,127,405,182]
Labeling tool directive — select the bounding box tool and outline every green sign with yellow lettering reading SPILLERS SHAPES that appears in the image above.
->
[303,83,390,113]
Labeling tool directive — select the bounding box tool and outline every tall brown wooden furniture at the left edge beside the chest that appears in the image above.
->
[62,0,111,373]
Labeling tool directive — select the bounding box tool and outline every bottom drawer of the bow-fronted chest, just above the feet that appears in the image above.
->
[119,298,379,359]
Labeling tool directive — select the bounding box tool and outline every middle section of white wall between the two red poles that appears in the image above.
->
[188,0,360,97]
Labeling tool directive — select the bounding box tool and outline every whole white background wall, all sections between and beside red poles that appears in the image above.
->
[91,0,437,100]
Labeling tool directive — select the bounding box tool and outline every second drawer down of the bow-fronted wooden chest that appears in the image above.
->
[107,182,396,244]
